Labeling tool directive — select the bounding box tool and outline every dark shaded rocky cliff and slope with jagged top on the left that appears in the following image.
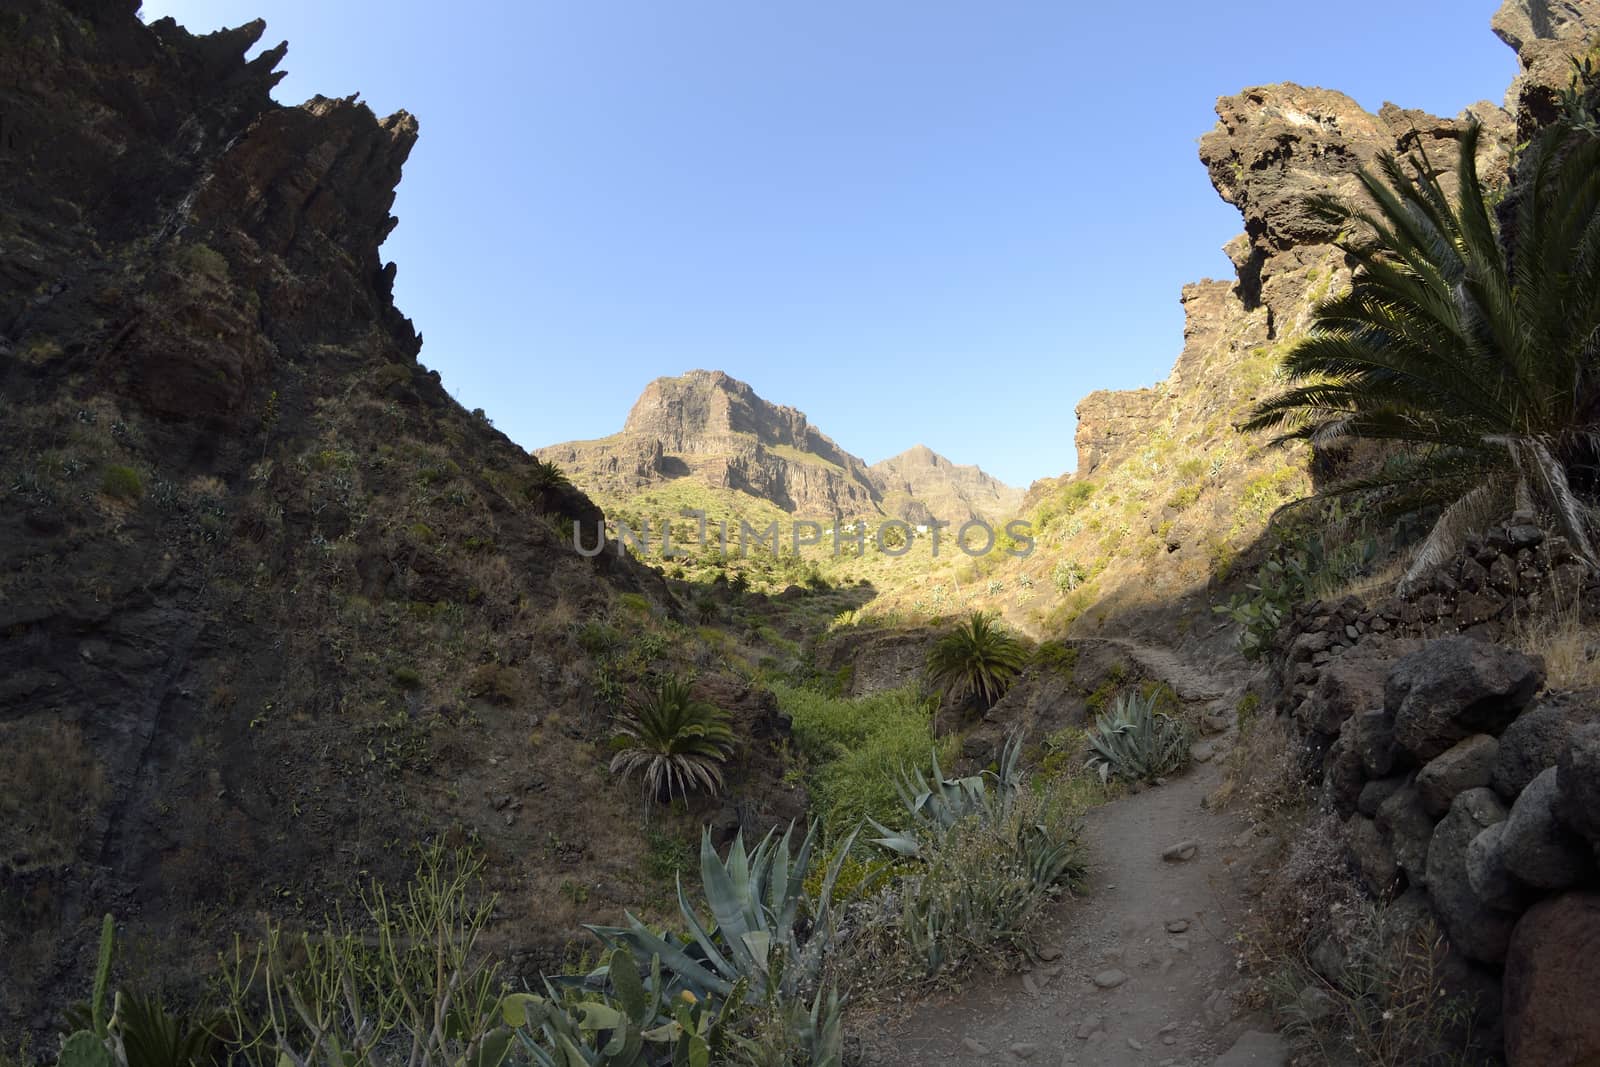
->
[0,0,794,1035]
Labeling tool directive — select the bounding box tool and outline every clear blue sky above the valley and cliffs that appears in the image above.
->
[144,0,1515,485]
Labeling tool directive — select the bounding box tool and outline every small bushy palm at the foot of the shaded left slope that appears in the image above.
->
[611,675,733,817]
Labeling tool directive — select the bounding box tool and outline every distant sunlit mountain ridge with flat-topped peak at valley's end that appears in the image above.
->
[536,371,1022,523]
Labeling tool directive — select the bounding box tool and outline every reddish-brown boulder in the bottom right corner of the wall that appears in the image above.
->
[1504,893,1600,1067]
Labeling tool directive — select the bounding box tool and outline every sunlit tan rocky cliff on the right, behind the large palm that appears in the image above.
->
[1004,83,1515,633]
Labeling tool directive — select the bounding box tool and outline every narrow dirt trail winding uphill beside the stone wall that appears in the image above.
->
[870,641,1286,1067]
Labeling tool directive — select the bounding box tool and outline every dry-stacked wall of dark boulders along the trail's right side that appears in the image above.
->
[1272,515,1600,1067]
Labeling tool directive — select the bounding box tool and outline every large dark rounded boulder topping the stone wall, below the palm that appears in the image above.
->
[1384,635,1544,763]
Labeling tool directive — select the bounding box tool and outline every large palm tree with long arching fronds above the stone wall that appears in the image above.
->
[1243,110,1600,582]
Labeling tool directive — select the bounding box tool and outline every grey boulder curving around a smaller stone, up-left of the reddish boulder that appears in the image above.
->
[1427,787,1515,963]
